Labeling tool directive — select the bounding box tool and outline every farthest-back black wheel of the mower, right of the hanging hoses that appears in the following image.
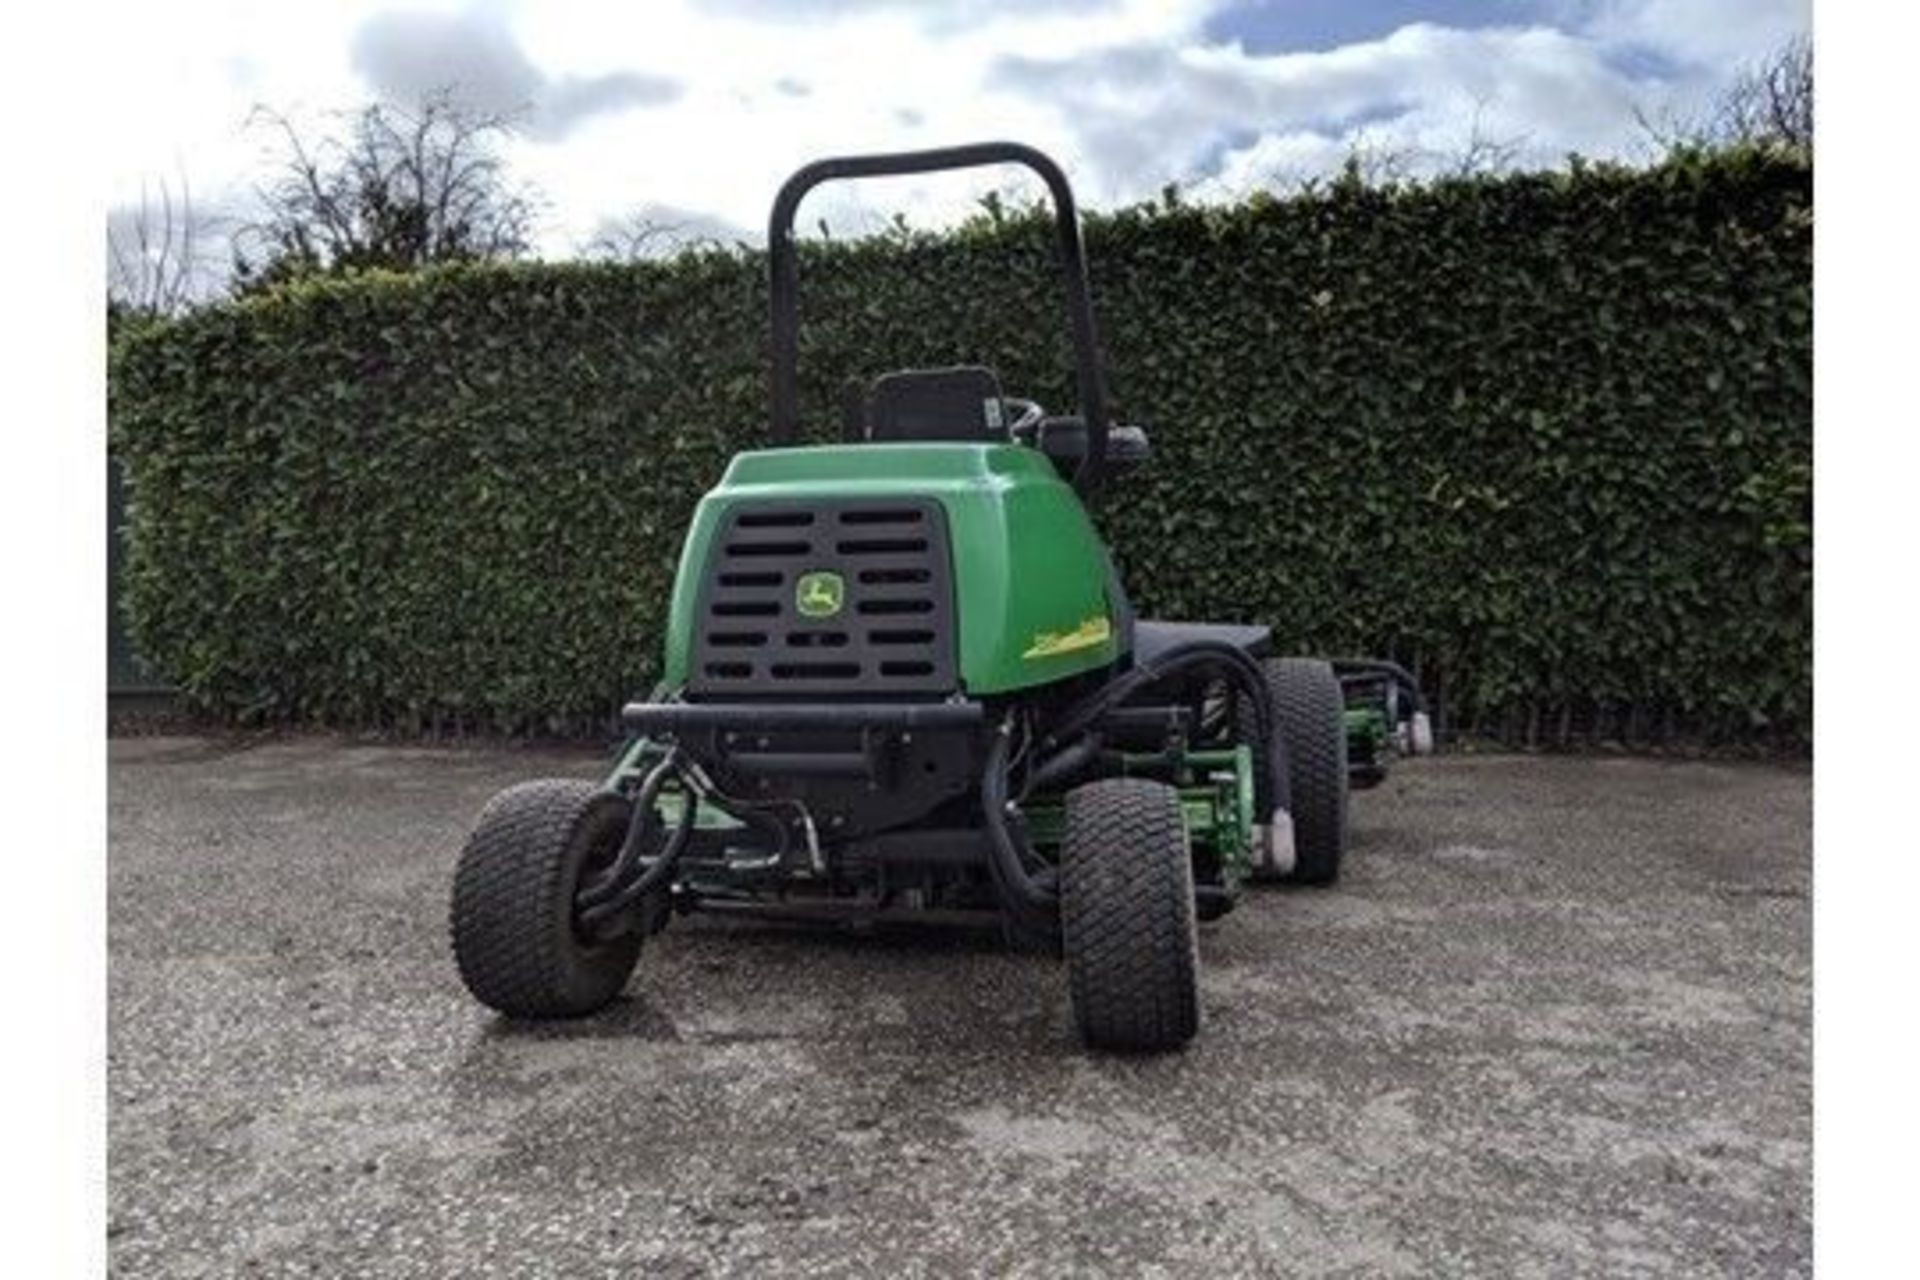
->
[1254,658,1348,885]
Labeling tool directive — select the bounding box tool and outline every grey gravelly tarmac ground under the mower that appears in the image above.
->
[108,739,1812,1276]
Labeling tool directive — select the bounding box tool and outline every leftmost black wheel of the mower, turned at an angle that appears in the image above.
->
[451,779,643,1017]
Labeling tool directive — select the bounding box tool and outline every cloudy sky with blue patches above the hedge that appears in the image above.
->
[106,0,1809,270]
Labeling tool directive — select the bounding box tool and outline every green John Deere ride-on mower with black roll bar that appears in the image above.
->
[451,142,1428,1050]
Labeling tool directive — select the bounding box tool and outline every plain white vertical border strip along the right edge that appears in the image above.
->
[1812,0,1920,1276]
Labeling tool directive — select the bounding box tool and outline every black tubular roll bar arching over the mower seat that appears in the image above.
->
[766,142,1108,493]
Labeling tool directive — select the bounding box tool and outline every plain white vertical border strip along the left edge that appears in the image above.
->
[0,6,108,1276]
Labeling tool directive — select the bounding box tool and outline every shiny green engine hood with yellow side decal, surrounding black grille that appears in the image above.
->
[664,443,1119,697]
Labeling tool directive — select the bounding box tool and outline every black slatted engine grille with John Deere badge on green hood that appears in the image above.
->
[687,501,958,697]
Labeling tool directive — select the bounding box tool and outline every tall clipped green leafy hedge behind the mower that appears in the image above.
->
[109,152,1812,745]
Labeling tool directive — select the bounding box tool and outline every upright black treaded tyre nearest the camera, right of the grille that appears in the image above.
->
[1060,777,1200,1052]
